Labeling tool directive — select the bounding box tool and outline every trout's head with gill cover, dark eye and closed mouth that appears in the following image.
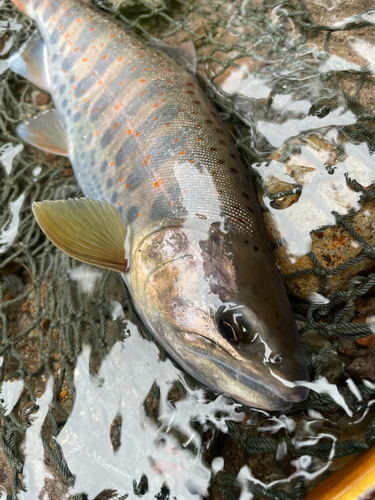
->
[131,227,308,411]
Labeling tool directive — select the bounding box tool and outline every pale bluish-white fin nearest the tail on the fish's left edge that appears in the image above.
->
[8,34,49,92]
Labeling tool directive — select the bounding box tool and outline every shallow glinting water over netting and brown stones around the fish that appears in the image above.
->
[0,0,375,500]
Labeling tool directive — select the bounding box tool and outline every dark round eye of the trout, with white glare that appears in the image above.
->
[218,306,256,344]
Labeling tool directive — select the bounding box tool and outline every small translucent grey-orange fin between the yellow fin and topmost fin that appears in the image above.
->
[17,109,68,156]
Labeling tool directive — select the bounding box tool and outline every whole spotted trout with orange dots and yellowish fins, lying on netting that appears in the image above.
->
[9,0,309,411]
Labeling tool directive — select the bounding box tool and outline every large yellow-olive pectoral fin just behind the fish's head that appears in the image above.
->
[33,198,128,272]
